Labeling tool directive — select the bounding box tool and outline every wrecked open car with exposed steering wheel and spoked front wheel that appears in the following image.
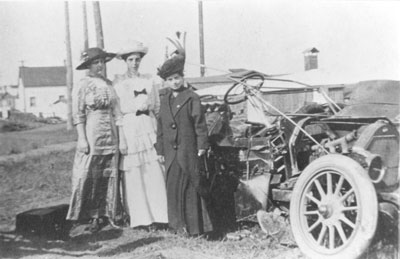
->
[198,73,400,258]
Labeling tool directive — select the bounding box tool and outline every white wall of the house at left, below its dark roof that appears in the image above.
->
[24,86,67,118]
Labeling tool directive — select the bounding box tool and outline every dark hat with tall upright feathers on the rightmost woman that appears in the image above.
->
[157,32,186,80]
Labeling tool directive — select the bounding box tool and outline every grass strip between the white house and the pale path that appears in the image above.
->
[0,123,77,156]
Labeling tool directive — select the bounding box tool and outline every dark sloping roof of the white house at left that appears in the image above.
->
[19,67,67,87]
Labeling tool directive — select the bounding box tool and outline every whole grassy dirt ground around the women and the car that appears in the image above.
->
[0,125,399,259]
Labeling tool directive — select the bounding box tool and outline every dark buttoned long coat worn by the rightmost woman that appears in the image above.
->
[156,89,208,187]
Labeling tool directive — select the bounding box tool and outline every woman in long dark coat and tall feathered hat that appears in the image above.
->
[156,35,212,238]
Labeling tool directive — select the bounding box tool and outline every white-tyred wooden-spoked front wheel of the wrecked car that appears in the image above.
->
[290,154,378,259]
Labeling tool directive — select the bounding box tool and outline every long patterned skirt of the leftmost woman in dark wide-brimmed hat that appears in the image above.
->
[67,152,120,220]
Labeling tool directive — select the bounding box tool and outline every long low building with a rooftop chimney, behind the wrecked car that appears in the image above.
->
[191,47,346,119]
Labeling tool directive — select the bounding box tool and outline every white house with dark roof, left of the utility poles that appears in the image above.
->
[16,66,67,119]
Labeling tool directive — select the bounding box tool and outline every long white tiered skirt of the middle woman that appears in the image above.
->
[120,113,168,227]
